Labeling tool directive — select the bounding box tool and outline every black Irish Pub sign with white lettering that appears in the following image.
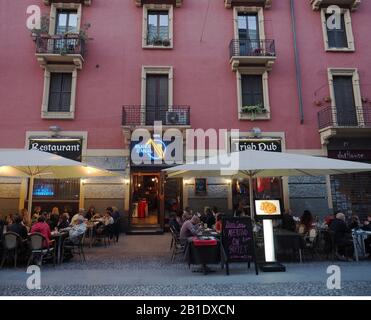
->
[231,138,282,152]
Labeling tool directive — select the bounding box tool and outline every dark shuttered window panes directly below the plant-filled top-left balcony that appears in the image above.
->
[48,72,72,112]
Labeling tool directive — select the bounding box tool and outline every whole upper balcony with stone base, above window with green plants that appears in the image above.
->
[229,39,276,70]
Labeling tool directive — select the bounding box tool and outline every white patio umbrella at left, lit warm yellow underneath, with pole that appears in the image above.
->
[0,150,119,213]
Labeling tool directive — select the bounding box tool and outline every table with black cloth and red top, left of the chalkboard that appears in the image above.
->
[185,237,228,275]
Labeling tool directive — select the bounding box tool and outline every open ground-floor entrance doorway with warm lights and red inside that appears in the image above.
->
[131,173,161,226]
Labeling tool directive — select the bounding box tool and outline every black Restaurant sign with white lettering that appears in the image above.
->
[29,138,82,162]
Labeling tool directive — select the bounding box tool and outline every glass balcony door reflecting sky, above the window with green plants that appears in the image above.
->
[238,13,260,56]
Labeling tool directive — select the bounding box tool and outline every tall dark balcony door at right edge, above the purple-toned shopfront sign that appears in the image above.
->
[333,76,358,127]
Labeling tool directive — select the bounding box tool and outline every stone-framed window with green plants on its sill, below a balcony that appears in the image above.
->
[236,67,270,120]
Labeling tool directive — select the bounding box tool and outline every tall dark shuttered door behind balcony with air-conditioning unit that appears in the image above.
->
[146,74,169,125]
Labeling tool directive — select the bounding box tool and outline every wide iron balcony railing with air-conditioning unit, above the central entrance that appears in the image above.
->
[122,105,191,126]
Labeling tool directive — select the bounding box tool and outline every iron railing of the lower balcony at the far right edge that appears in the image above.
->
[318,106,371,130]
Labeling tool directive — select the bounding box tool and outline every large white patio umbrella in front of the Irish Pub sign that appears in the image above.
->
[164,150,371,218]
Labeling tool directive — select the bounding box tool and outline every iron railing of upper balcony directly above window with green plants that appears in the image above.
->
[229,39,276,58]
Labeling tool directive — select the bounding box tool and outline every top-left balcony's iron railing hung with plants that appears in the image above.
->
[36,35,85,56]
